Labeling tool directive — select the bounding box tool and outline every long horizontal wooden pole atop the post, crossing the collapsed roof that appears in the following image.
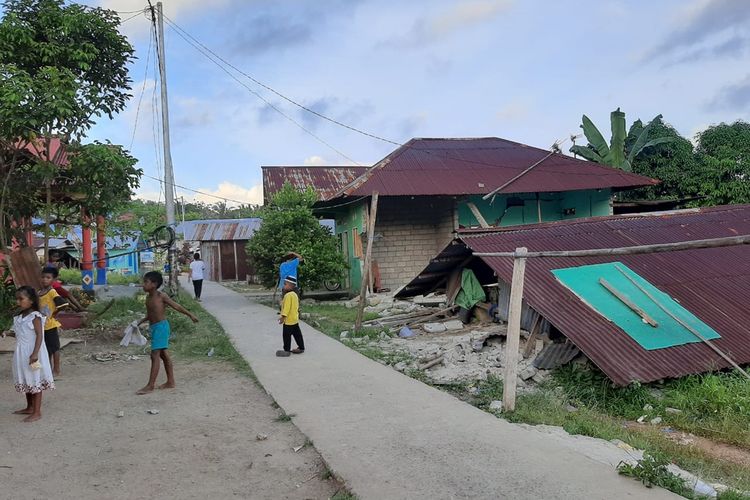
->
[474,234,750,259]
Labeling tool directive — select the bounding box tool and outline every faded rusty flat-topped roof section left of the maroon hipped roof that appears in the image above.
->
[261,166,368,203]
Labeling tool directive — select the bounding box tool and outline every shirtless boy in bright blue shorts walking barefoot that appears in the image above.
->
[136,271,198,394]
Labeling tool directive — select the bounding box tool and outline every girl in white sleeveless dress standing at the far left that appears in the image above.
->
[2,286,55,422]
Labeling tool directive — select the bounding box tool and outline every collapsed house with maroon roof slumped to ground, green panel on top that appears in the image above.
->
[397,205,750,385]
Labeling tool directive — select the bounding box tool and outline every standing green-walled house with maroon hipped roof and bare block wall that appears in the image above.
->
[263,137,657,291]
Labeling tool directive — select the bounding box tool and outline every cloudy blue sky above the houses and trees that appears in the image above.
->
[78,0,750,203]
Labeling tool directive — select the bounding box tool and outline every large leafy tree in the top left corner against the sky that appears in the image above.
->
[0,0,133,245]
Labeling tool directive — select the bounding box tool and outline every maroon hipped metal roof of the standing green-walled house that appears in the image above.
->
[335,137,658,197]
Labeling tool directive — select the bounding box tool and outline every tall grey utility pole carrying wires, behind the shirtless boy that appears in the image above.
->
[148,0,177,291]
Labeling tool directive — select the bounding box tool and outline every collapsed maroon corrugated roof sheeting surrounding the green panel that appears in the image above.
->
[404,205,750,385]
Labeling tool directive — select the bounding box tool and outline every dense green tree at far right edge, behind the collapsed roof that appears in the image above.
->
[695,120,750,205]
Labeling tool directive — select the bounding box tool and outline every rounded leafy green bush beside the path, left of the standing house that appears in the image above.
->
[247,183,347,289]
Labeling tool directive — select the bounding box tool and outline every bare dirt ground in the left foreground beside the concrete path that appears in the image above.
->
[0,343,341,499]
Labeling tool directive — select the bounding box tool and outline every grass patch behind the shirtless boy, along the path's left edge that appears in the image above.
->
[89,291,257,382]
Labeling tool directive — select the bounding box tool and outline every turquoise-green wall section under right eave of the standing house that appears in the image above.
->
[458,189,612,227]
